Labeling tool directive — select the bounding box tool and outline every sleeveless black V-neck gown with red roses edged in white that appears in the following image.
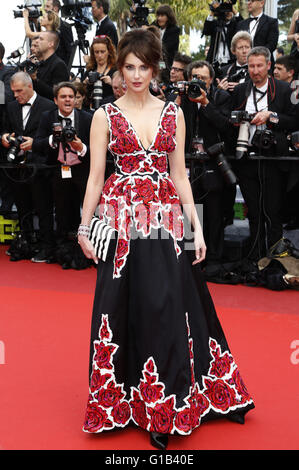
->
[83,102,254,435]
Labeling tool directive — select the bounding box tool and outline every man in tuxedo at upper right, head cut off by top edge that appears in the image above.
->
[237,0,279,65]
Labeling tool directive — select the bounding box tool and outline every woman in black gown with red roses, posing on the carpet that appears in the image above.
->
[78,29,254,449]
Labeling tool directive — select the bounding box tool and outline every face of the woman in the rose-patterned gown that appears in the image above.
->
[122,52,153,93]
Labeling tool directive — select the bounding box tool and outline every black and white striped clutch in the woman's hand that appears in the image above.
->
[89,216,117,261]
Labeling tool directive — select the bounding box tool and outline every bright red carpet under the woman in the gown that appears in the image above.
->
[0,246,299,450]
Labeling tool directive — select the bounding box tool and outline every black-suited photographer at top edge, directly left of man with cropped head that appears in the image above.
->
[202,0,243,65]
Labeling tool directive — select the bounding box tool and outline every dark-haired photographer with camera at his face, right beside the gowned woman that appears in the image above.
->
[181,61,235,282]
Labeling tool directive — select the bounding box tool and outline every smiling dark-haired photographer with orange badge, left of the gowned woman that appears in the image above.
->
[33,82,92,242]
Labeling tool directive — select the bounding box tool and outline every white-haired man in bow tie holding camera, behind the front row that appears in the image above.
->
[216,31,252,92]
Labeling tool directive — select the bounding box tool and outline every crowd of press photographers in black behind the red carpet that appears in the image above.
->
[0,0,299,290]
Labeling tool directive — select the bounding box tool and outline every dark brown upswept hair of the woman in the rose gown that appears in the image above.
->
[117,28,162,76]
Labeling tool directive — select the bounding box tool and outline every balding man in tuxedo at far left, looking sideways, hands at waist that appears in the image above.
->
[2,72,55,261]
